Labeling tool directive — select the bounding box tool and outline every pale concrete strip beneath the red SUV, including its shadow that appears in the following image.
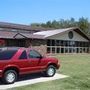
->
[0,73,68,90]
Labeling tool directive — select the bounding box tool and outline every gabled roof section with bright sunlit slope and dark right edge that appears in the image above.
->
[34,27,90,40]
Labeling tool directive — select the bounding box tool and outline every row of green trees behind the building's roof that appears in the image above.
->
[31,17,90,36]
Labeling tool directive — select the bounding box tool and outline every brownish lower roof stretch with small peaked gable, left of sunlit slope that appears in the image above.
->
[0,31,44,39]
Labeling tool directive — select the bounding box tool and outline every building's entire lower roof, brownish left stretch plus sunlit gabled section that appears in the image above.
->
[0,27,90,40]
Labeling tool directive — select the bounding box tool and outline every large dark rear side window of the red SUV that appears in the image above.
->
[0,50,17,60]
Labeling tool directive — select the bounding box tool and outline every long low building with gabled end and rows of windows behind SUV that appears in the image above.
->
[0,22,90,54]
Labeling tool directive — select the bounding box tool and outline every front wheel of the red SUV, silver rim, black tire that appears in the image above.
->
[44,65,56,77]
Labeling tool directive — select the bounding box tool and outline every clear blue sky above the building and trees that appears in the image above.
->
[0,0,90,24]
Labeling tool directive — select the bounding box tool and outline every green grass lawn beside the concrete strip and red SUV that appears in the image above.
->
[11,55,90,90]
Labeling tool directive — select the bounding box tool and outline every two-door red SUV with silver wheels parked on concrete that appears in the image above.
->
[0,48,60,84]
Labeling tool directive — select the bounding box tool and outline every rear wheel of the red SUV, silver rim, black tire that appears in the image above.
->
[2,70,17,84]
